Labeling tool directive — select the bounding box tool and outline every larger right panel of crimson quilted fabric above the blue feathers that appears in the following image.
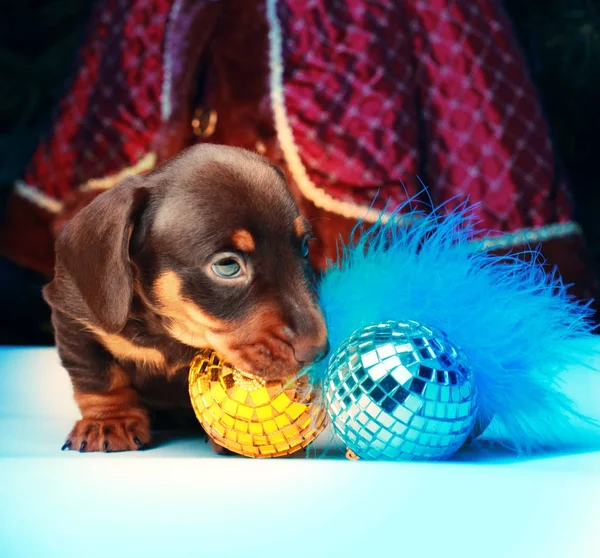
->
[277,0,571,231]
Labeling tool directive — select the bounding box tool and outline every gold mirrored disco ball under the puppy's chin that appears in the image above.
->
[189,351,327,457]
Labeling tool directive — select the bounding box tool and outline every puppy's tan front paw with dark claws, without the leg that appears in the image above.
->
[62,414,150,452]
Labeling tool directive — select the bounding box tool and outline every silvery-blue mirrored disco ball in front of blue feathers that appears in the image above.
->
[325,320,477,460]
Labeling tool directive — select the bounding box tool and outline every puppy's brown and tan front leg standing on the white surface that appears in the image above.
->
[54,318,150,452]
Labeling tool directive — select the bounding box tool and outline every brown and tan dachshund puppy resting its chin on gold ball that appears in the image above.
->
[44,145,327,451]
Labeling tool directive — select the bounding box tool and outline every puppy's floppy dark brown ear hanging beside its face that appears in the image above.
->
[45,177,148,333]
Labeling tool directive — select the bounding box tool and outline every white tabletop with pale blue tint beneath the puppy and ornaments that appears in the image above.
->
[0,349,600,558]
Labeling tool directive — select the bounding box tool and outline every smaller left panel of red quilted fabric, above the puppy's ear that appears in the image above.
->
[25,0,172,200]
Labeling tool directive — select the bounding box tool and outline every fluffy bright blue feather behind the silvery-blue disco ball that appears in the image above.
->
[310,202,594,452]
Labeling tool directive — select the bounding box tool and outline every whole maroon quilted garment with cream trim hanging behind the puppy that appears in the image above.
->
[0,0,590,306]
